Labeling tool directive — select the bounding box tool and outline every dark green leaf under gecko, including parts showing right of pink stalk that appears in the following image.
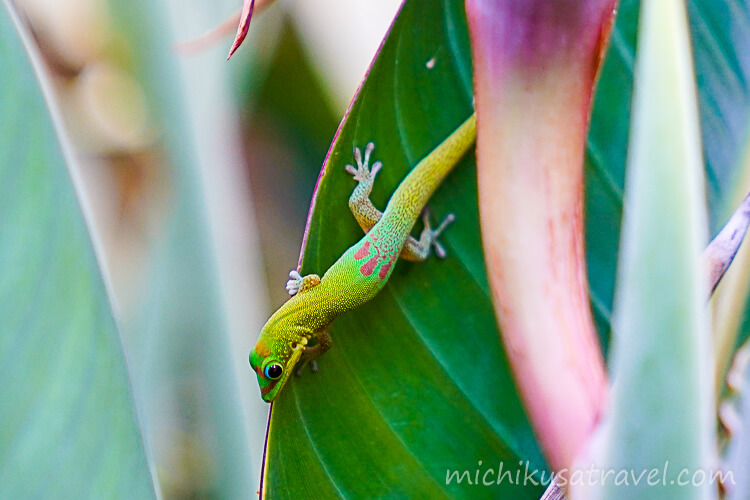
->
[264,0,750,498]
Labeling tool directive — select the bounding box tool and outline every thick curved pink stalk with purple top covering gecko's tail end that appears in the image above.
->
[466,0,616,469]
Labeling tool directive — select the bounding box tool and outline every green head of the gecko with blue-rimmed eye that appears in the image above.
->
[250,339,307,403]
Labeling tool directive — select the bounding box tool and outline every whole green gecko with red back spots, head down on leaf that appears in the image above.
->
[250,114,476,403]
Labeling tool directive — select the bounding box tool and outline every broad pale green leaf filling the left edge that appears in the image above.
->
[0,2,155,498]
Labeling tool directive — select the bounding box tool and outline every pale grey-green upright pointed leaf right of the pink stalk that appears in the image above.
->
[582,0,716,499]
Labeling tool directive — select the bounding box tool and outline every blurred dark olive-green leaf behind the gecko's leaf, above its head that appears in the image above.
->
[238,17,339,306]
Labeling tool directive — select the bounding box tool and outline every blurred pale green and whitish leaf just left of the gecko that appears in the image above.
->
[105,0,276,498]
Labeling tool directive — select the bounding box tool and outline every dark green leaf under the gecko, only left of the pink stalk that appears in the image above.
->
[264,1,543,498]
